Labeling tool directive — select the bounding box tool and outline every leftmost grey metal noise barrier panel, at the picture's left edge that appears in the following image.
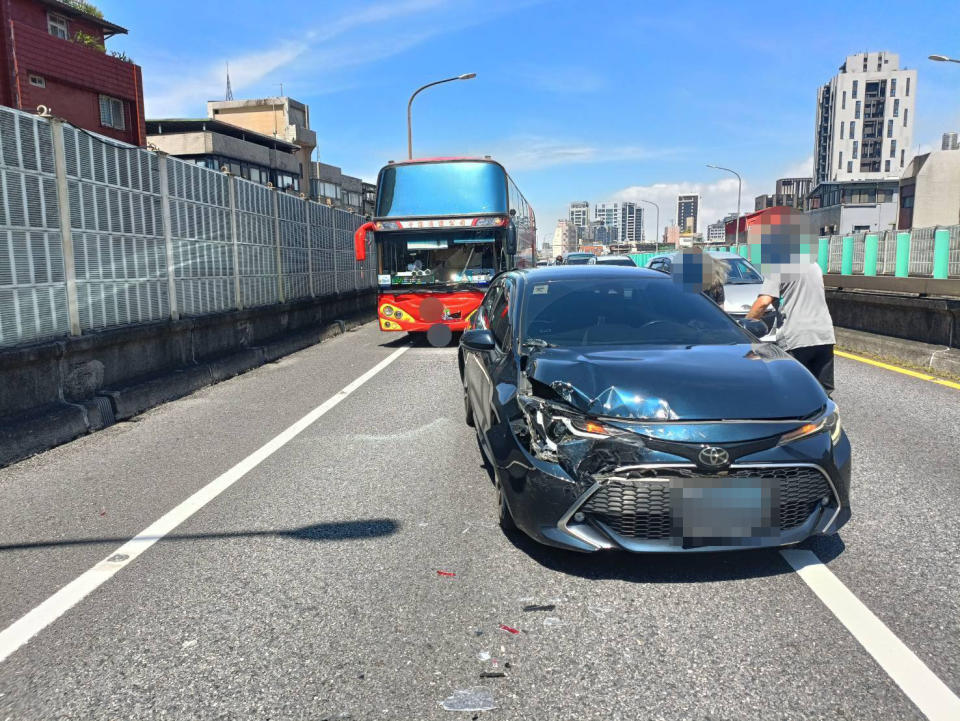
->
[0,108,69,346]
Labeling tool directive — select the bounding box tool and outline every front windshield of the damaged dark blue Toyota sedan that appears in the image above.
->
[521,274,749,346]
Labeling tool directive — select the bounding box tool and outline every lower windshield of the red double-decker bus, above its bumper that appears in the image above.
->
[379,231,500,287]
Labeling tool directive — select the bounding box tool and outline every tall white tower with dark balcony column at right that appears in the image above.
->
[813,52,917,185]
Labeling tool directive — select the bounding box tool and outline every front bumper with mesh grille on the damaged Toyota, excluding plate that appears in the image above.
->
[488,424,850,553]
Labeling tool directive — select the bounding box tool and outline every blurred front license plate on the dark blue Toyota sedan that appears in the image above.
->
[670,477,780,548]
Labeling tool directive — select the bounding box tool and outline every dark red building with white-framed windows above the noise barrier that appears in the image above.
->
[0,0,146,145]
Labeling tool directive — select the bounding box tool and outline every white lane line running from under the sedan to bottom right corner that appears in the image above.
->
[780,549,960,721]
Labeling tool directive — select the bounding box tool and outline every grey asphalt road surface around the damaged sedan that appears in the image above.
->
[0,325,960,720]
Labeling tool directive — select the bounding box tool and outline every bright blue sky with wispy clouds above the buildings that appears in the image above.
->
[97,0,960,245]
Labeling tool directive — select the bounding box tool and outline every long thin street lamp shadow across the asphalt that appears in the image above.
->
[0,518,400,553]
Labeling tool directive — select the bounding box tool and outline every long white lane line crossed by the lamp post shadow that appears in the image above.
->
[0,346,410,663]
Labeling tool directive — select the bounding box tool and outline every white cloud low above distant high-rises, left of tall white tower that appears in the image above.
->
[612,177,757,240]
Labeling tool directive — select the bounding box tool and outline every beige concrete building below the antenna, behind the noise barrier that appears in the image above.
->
[207,97,317,193]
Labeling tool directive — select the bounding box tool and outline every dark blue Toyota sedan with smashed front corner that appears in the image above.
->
[459,265,850,552]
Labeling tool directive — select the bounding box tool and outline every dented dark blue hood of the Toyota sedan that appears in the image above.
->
[526,343,826,421]
